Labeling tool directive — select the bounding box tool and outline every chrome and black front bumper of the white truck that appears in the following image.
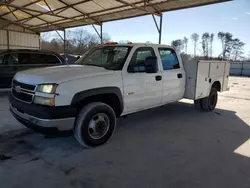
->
[9,96,75,134]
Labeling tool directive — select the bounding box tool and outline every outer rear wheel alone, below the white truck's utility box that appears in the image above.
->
[201,88,218,111]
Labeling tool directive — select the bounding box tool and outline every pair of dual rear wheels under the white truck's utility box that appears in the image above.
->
[194,88,218,111]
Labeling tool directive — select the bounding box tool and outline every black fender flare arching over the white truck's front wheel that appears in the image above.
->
[71,87,124,112]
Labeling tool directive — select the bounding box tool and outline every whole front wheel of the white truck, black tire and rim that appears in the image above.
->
[74,102,116,148]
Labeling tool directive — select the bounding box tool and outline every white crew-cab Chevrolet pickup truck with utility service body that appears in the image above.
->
[9,44,230,147]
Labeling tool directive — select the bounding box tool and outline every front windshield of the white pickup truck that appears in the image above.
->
[75,46,131,70]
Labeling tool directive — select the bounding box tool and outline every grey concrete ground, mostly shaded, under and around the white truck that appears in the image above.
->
[0,77,250,188]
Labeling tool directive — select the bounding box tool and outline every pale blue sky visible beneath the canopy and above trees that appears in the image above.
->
[46,0,250,56]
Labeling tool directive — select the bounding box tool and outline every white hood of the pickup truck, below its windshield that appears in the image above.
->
[14,65,114,85]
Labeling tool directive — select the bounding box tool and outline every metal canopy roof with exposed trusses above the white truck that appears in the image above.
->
[0,0,230,32]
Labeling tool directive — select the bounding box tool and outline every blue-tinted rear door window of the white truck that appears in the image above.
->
[158,48,180,70]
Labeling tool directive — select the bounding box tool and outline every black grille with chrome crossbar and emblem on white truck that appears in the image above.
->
[11,80,36,103]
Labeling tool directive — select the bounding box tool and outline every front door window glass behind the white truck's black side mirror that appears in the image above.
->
[127,47,155,73]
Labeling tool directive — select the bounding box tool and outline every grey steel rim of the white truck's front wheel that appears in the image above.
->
[88,113,110,140]
